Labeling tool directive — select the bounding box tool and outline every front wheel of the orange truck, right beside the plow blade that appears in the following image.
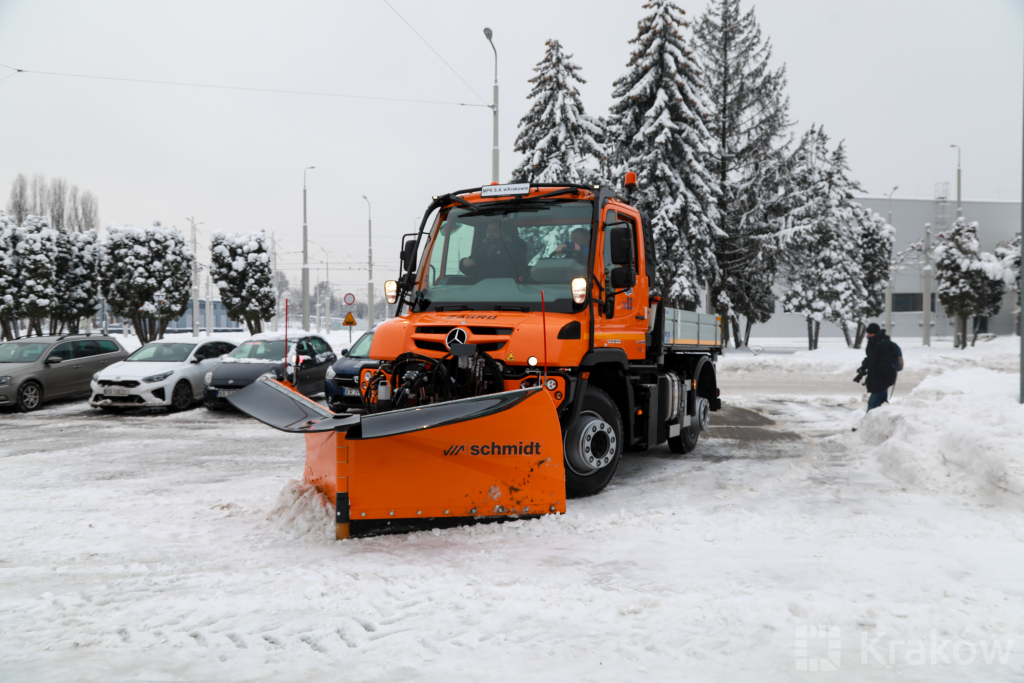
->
[563,387,624,498]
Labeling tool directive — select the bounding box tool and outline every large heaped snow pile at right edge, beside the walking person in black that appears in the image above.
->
[853,368,1024,505]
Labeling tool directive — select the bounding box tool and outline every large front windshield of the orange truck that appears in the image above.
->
[414,201,593,312]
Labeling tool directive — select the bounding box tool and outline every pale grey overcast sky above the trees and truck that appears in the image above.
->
[0,0,1024,292]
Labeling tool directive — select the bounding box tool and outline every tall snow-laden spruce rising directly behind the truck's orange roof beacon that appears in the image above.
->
[611,0,720,310]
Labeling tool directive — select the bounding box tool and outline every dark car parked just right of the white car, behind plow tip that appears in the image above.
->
[203,333,338,411]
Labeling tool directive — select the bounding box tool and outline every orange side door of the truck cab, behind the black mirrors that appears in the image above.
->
[594,210,648,359]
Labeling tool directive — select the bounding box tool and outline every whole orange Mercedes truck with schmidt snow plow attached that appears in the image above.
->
[228,180,722,539]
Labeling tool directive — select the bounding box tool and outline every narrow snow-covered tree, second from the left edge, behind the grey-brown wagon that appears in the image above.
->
[14,215,59,336]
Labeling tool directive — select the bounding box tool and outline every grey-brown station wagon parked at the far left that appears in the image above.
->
[0,334,128,412]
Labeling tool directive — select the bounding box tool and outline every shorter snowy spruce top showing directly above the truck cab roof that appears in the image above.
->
[512,40,604,183]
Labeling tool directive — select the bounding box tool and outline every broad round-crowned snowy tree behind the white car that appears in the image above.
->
[101,221,196,344]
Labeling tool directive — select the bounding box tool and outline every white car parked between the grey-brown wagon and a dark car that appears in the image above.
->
[89,337,236,411]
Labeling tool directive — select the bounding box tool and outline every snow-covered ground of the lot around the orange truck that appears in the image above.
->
[0,335,1024,683]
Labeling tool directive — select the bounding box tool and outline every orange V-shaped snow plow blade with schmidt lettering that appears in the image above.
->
[228,379,565,539]
